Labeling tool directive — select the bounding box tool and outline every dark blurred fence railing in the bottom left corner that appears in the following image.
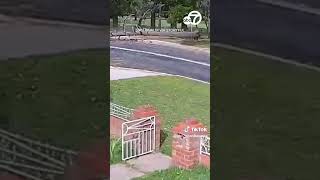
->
[0,129,77,180]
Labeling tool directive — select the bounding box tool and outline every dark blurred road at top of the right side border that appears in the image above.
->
[214,0,320,65]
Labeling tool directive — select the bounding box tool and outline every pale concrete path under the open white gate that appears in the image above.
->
[110,153,172,180]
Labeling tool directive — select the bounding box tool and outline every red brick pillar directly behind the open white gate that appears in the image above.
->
[131,105,161,152]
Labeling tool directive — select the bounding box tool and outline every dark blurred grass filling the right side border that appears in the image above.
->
[212,48,320,180]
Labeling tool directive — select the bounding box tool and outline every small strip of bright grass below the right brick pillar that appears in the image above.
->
[134,167,210,180]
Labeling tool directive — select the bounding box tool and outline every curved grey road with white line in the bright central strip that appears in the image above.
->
[110,41,210,82]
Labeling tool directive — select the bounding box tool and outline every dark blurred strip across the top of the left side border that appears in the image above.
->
[0,0,109,25]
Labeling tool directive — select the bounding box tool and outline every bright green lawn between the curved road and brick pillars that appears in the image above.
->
[110,77,210,155]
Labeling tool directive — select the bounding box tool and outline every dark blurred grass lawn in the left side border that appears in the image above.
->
[0,49,108,149]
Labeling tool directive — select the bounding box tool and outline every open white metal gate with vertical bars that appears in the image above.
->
[122,116,156,160]
